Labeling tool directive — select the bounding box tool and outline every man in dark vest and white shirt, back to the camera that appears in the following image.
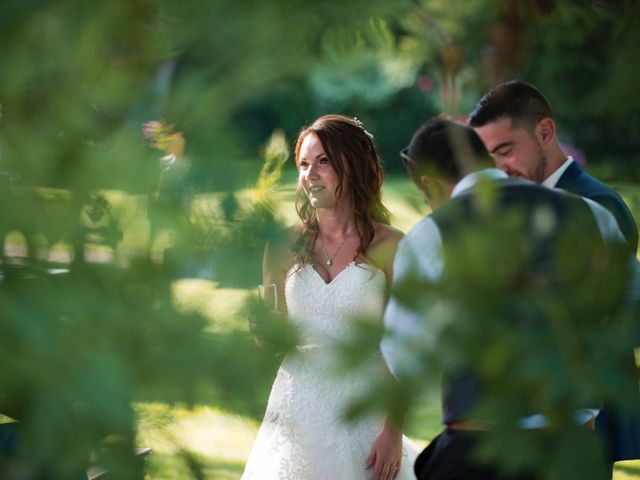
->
[381,118,629,480]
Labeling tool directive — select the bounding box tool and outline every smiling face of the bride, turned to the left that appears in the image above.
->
[298,133,345,208]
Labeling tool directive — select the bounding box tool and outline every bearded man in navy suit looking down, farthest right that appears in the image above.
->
[469,80,640,470]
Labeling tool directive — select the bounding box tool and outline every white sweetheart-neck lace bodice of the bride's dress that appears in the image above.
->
[285,262,386,348]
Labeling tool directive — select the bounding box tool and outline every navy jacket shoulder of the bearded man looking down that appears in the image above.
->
[556,162,638,254]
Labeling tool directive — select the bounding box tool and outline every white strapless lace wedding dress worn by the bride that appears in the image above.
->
[242,262,418,480]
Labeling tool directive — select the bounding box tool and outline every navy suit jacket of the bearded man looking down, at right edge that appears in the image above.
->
[556,162,640,462]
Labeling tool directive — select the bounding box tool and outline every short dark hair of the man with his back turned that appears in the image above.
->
[406,117,489,181]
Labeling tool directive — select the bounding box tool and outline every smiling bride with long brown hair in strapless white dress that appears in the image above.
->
[242,115,418,480]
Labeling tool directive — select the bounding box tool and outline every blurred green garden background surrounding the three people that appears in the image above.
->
[0,0,640,479]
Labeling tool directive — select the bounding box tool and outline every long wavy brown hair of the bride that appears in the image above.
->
[292,115,391,266]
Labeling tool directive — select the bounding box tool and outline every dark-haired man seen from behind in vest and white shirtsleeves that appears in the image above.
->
[381,118,627,480]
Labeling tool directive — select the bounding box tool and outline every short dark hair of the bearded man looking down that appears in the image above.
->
[468,80,553,128]
